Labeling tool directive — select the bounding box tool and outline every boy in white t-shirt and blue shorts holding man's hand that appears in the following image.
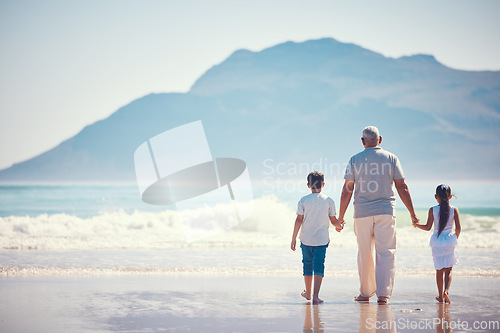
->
[290,171,344,304]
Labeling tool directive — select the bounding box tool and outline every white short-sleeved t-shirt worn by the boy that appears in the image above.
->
[297,192,337,246]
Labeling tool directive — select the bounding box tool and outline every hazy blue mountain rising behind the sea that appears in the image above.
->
[0,38,500,182]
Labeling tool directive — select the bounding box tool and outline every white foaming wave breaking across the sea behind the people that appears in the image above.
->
[0,195,500,250]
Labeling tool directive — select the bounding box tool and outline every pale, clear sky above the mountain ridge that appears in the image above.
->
[0,0,500,169]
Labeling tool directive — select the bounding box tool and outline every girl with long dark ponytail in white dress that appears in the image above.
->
[413,184,462,303]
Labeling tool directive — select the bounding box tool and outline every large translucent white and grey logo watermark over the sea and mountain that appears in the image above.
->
[134,120,253,242]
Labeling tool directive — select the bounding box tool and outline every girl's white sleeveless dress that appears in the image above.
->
[429,206,458,270]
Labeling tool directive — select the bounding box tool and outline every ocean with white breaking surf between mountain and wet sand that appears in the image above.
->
[0,181,500,278]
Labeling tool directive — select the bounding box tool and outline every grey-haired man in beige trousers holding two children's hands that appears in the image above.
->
[339,126,419,304]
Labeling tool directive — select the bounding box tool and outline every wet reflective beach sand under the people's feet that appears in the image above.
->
[0,274,500,333]
